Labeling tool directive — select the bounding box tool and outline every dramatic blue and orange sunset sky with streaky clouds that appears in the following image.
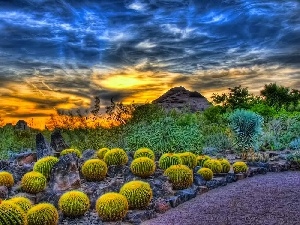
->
[0,0,300,127]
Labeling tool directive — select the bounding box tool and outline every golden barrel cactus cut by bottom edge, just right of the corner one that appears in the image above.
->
[27,203,58,225]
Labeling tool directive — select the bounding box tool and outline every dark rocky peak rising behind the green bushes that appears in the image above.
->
[152,86,211,112]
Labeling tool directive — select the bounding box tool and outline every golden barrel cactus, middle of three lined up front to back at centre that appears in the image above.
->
[130,157,156,178]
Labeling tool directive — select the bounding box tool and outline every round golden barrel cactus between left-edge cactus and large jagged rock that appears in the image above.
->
[21,171,47,194]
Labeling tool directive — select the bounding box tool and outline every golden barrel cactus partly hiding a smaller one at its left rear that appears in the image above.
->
[104,148,128,166]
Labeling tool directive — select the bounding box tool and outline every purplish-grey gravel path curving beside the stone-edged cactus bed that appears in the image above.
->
[142,171,300,225]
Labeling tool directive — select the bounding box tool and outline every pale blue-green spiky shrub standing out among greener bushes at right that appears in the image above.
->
[228,109,263,150]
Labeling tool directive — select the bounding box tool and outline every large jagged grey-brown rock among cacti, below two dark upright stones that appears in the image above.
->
[48,154,81,192]
